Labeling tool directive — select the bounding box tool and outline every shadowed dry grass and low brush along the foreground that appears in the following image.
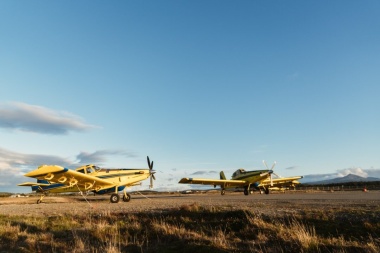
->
[0,203,380,253]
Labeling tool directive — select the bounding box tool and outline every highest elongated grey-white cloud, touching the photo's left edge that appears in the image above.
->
[0,102,96,135]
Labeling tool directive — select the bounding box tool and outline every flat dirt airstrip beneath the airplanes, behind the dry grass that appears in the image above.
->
[0,191,380,217]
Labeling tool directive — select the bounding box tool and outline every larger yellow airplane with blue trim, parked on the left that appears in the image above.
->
[19,157,156,204]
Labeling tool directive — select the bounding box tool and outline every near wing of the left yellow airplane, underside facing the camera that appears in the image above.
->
[23,165,115,191]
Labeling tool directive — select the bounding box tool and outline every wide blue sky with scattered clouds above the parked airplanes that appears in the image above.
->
[0,0,380,192]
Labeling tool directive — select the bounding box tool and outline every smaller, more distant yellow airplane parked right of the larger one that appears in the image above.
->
[178,162,276,195]
